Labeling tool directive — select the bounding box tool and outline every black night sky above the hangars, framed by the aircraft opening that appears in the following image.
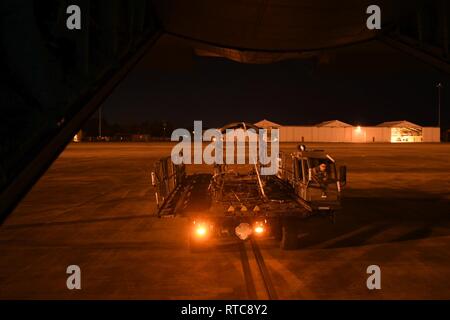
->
[103,37,450,127]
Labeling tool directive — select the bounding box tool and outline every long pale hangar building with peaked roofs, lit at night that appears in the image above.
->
[255,119,440,143]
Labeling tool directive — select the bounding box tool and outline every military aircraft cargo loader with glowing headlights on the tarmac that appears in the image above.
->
[152,145,346,251]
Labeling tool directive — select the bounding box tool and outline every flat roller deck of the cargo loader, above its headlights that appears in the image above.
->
[158,173,311,217]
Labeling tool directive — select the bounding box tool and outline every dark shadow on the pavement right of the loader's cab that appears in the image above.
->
[299,190,450,249]
